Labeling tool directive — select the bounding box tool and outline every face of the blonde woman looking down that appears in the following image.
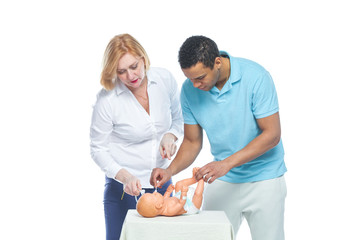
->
[116,53,145,89]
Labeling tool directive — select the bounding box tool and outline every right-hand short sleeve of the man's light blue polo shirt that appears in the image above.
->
[252,72,279,119]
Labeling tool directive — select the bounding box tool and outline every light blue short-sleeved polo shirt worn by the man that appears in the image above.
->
[181,52,286,183]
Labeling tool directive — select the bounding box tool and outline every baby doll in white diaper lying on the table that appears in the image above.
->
[136,168,204,217]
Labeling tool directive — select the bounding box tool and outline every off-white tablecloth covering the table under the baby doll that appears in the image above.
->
[120,210,234,240]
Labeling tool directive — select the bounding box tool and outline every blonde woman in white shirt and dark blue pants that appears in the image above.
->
[90,34,183,240]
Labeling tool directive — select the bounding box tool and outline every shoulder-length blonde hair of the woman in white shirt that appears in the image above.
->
[100,33,150,90]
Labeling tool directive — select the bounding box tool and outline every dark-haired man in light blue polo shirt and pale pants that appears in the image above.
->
[150,36,287,240]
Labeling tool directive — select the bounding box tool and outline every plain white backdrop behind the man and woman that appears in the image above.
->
[0,0,360,240]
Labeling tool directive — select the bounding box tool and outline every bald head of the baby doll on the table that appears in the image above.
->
[136,192,164,217]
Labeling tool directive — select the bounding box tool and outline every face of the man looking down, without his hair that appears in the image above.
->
[181,62,220,91]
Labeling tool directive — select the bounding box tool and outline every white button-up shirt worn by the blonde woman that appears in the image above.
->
[90,68,183,188]
